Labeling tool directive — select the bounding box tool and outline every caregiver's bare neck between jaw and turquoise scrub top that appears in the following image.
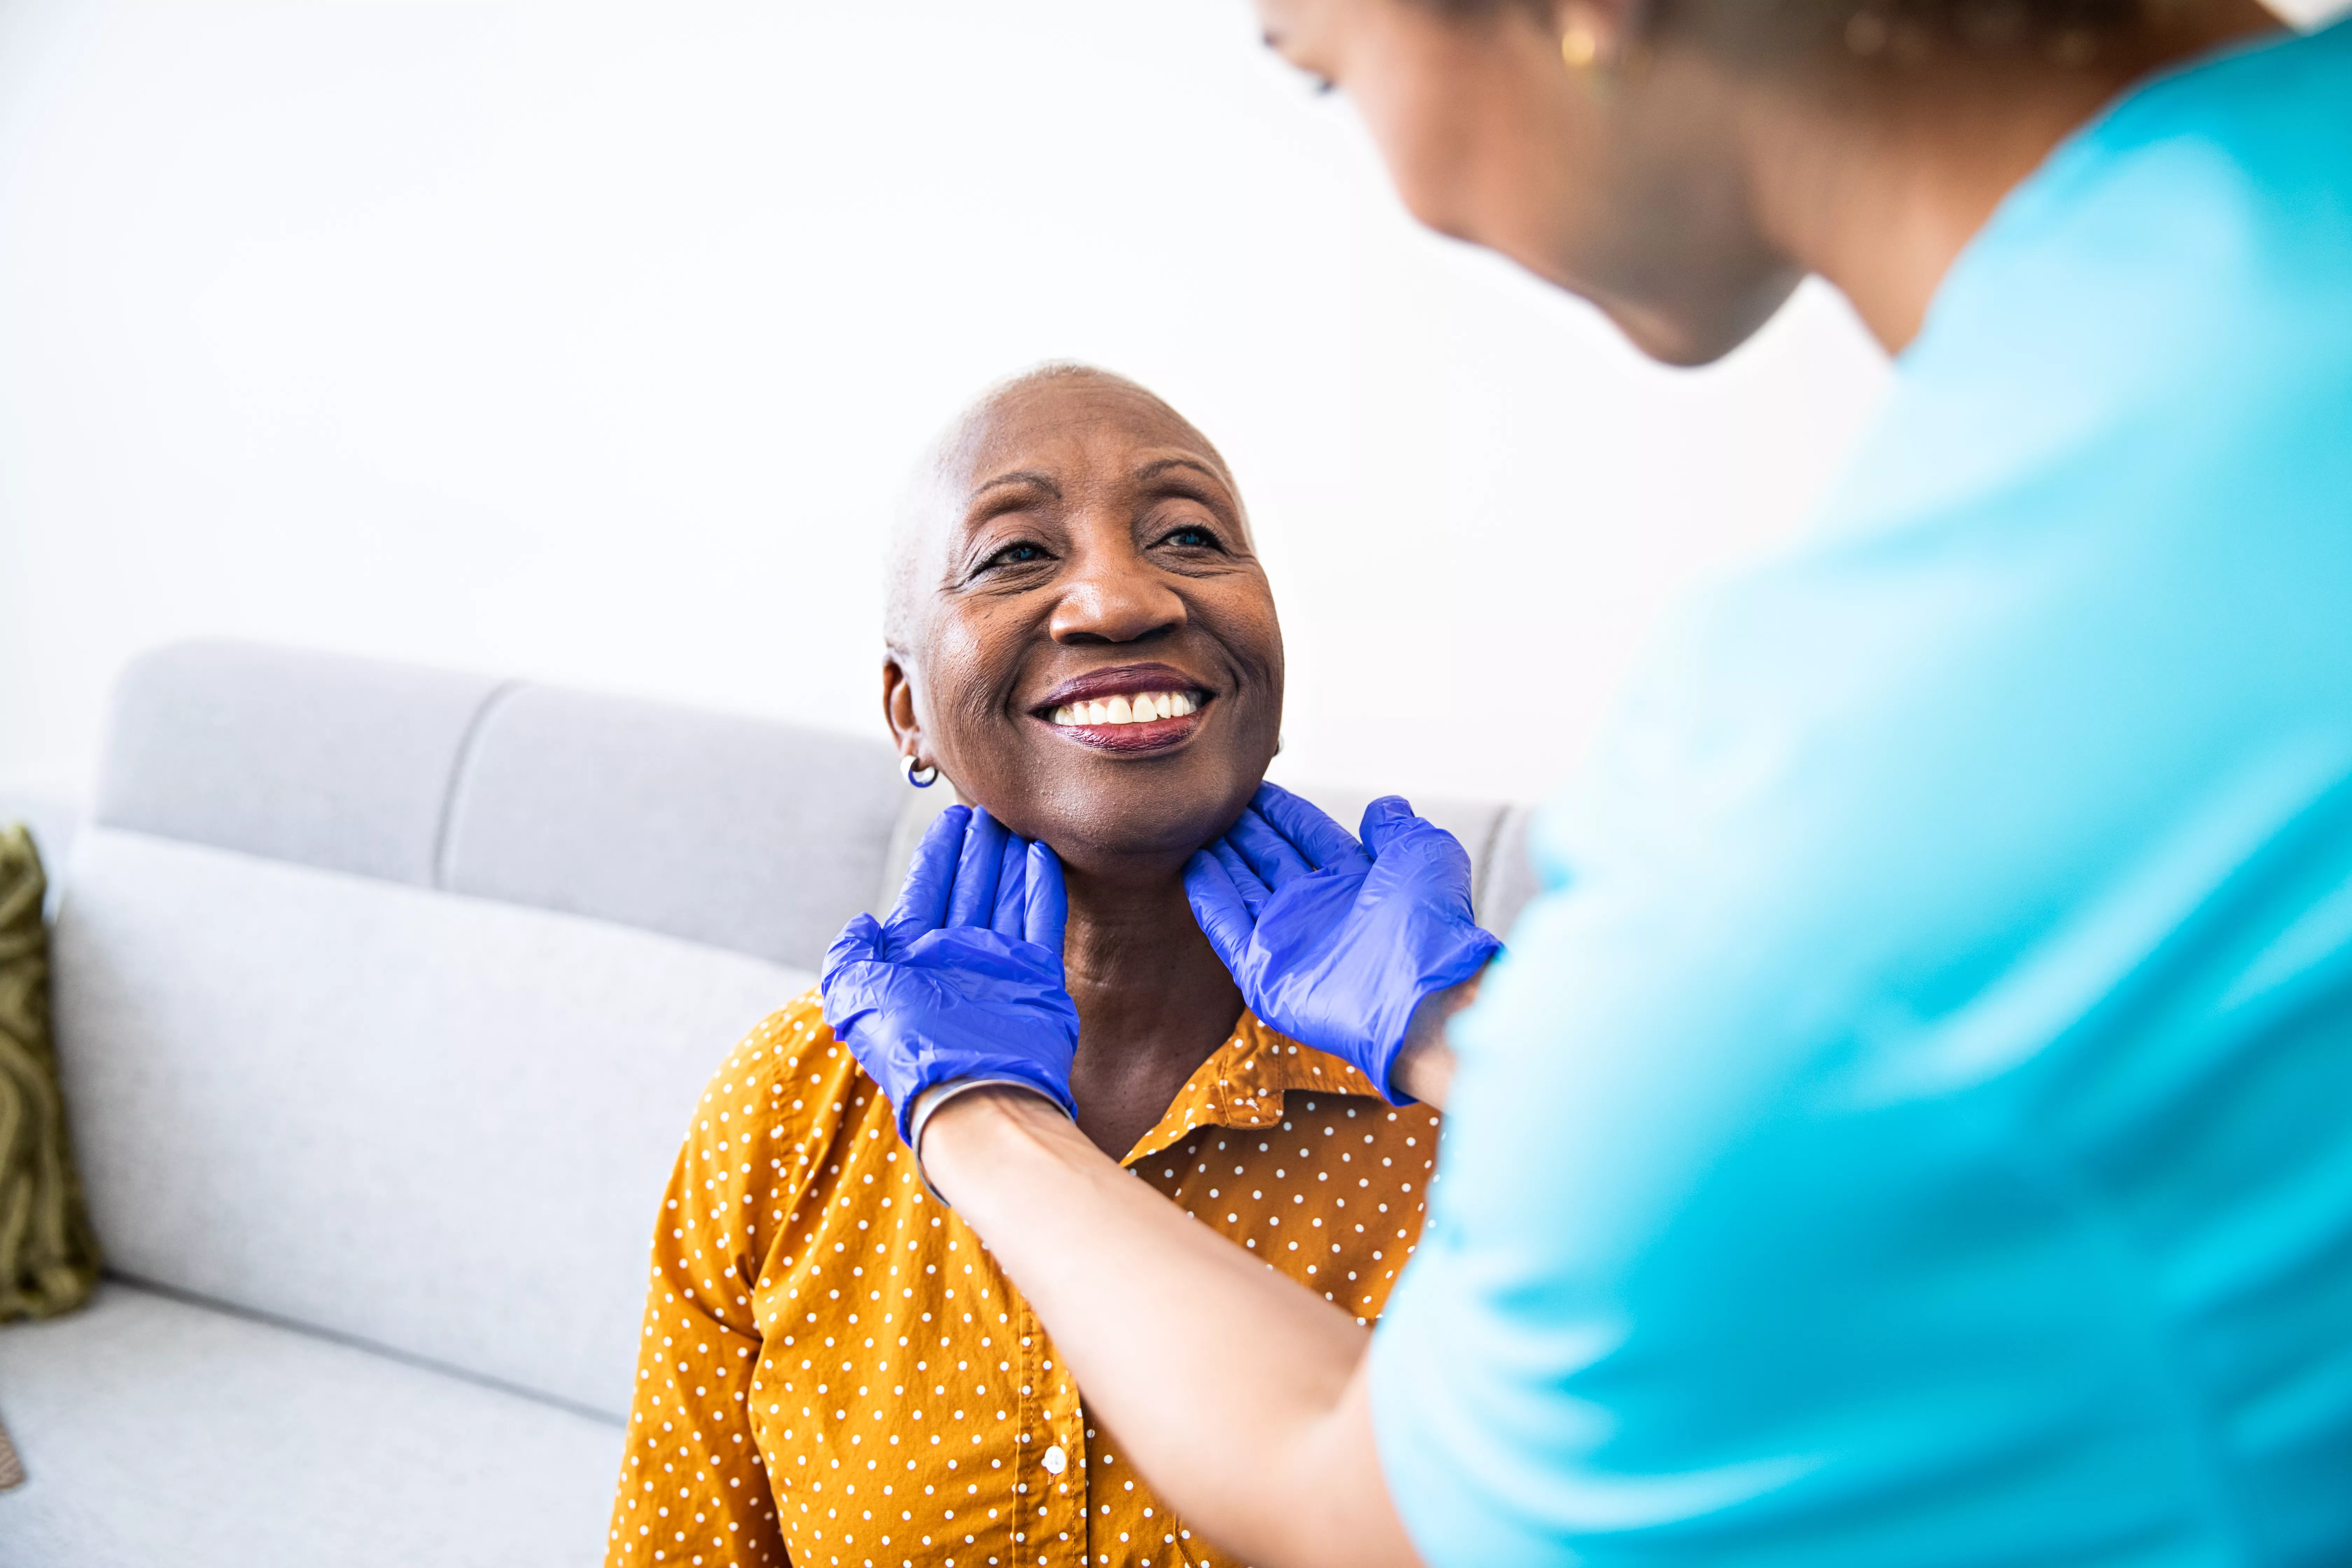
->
[1743,0,2279,352]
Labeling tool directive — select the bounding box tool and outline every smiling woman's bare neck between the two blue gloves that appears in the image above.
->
[1063,867,1242,1159]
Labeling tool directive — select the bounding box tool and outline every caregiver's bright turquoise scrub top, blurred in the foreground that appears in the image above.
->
[1373,26,2352,1568]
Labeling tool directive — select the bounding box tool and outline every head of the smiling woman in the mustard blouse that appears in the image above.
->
[882,374,1282,877]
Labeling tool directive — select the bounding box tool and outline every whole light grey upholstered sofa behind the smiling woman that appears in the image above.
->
[0,644,1529,1568]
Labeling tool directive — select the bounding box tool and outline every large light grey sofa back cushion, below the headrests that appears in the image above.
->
[54,827,811,1415]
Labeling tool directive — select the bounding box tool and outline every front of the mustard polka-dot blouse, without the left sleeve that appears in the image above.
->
[750,1077,1435,1566]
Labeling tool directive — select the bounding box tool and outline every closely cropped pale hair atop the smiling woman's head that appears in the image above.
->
[882,362,1237,658]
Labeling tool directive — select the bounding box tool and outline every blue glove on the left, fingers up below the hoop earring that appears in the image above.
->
[819,806,1077,1138]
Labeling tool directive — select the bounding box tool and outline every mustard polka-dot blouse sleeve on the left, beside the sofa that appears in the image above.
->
[604,1020,818,1568]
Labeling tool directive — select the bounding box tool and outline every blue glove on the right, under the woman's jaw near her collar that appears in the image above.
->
[1183,785,1503,1105]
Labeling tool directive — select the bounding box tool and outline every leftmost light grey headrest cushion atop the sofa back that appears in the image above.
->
[94,642,499,884]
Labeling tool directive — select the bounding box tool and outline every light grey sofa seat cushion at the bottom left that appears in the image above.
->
[0,1281,621,1568]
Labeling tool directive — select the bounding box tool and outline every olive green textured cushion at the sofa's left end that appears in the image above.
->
[0,827,99,1321]
